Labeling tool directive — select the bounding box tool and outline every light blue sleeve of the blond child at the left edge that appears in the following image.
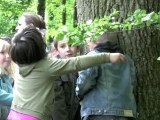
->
[0,89,13,107]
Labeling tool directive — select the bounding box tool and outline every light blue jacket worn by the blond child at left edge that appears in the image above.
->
[0,75,13,120]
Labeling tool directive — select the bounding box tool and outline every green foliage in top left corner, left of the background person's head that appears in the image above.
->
[0,0,37,36]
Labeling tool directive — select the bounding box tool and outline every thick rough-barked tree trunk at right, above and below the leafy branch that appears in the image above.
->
[77,0,160,120]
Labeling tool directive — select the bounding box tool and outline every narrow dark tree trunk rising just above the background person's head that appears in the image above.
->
[37,0,45,18]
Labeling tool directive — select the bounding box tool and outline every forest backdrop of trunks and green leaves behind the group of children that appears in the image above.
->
[0,0,160,120]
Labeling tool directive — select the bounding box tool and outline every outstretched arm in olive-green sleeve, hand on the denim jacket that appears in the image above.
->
[49,53,126,76]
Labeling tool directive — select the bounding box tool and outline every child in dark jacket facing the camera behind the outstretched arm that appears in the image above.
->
[50,40,80,120]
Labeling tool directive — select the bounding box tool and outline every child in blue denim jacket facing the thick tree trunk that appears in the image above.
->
[76,33,136,120]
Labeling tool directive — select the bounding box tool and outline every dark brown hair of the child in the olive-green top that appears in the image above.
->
[11,26,46,64]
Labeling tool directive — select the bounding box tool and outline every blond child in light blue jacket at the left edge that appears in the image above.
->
[0,38,13,120]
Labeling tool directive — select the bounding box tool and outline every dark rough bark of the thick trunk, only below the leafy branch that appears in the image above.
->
[120,28,160,120]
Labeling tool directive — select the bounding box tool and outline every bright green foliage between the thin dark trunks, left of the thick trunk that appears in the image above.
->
[45,0,74,42]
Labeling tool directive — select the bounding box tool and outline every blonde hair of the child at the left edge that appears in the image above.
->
[0,39,15,77]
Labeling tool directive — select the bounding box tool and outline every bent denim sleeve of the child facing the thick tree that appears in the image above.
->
[76,67,98,97]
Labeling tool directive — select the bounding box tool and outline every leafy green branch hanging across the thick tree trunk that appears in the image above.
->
[52,9,160,45]
